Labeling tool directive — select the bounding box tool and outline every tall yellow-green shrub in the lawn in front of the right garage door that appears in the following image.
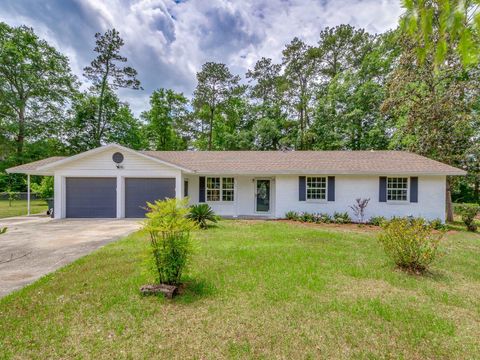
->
[143,199,197,285]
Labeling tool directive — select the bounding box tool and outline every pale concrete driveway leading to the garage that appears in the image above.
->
[0,216,139,297]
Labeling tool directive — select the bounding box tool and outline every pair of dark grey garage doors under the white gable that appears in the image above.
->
[66,177,175,218]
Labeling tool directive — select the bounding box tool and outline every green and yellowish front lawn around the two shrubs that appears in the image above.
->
[0,221,480,359]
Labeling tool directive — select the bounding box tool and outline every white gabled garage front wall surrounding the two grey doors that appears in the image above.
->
[54,148,183,219]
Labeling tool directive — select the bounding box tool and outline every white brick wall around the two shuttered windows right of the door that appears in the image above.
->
[275,175,446,221]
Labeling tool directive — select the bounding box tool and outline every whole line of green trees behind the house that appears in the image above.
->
[0,4,480,211]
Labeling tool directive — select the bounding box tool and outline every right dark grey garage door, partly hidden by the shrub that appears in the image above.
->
[125,178,175,218]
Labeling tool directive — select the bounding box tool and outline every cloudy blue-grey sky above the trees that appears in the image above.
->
[0,0,402,115]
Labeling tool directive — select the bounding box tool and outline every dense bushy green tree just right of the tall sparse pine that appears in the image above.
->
[142,89,190,150]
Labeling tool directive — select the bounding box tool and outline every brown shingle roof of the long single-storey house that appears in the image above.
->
[7,151,466,175]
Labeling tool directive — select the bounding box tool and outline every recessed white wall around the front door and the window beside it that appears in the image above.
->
[184,174,276,217]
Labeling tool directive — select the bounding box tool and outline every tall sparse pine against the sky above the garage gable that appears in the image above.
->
[83,29,142,146]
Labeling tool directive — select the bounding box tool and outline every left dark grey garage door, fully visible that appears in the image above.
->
[66,178,117,218]
